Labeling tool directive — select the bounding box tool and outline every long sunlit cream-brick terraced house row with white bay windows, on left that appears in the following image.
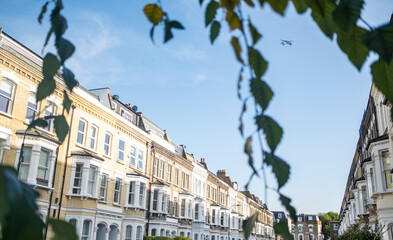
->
[0,28,274,240]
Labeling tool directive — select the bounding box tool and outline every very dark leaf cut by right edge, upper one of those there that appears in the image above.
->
[363,22,393,63]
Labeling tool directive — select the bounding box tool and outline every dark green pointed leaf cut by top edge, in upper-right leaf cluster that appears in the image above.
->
[333,0,364,34]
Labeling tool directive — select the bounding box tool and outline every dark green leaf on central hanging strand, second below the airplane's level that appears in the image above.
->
[250,78,273,111]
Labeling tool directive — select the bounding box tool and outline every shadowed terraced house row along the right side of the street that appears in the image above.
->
[338,82,393,240]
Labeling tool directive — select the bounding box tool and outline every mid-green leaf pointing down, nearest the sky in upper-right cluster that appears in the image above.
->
[337,26,369,71]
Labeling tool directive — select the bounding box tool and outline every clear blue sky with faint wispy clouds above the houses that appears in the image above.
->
[0,0,393,213]
